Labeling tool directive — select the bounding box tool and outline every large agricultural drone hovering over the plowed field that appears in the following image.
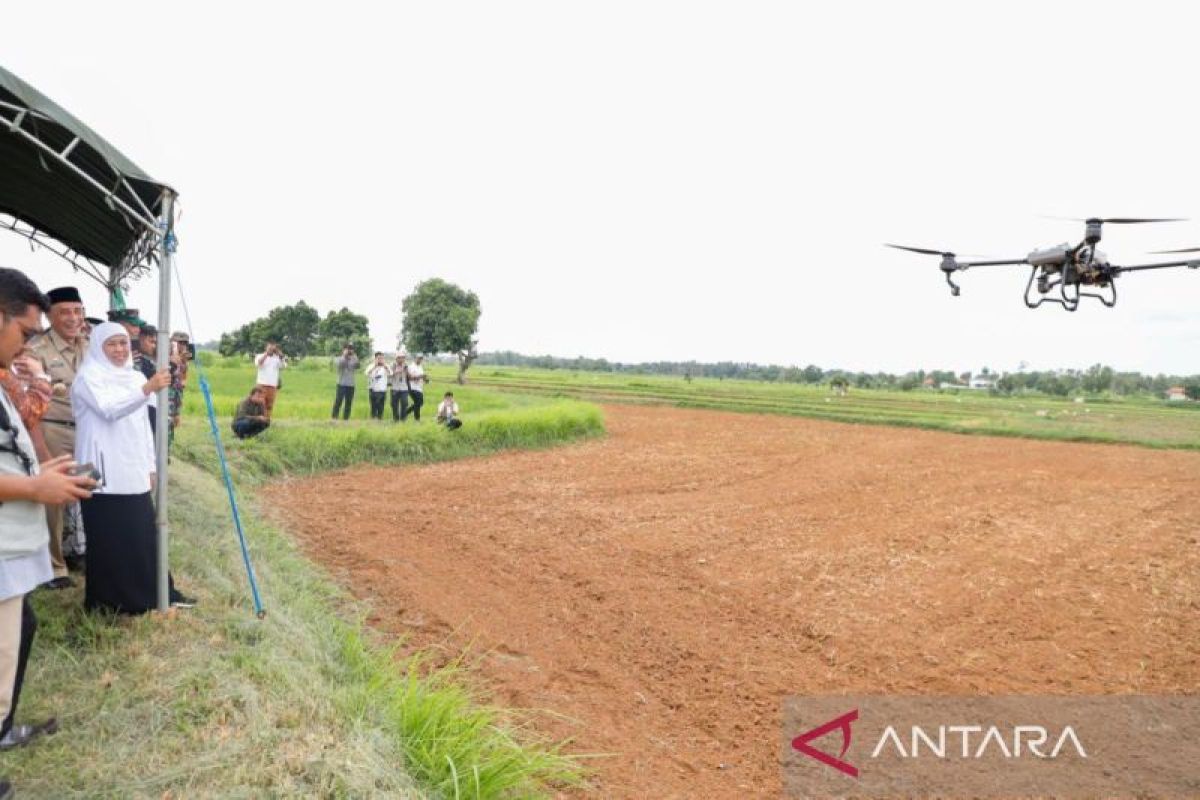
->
[887,217,1200,311]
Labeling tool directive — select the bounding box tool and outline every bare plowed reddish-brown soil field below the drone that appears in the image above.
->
[268,405,1200,798]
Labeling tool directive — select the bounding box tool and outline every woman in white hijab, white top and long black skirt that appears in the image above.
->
[71,323,193,614]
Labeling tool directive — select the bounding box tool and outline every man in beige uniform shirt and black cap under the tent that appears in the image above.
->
[29,287,88,589]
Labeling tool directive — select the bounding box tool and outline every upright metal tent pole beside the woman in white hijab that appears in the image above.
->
[155,188,175,612]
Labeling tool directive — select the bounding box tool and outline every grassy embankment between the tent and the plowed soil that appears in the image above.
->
[7,371,604,799]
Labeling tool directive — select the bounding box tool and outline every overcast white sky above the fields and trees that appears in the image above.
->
[0,0,1200,373]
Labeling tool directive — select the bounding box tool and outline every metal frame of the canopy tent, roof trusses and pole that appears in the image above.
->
[0,90,175,612]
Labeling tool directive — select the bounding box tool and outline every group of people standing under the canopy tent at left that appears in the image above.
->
[0,269,194,786]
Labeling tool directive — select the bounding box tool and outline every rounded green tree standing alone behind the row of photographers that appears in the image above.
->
[401,278,480,384]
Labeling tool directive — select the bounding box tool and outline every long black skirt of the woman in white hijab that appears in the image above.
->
[79,492,178,614]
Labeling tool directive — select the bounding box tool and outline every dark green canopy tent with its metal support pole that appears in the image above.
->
[0,67,175,610]
